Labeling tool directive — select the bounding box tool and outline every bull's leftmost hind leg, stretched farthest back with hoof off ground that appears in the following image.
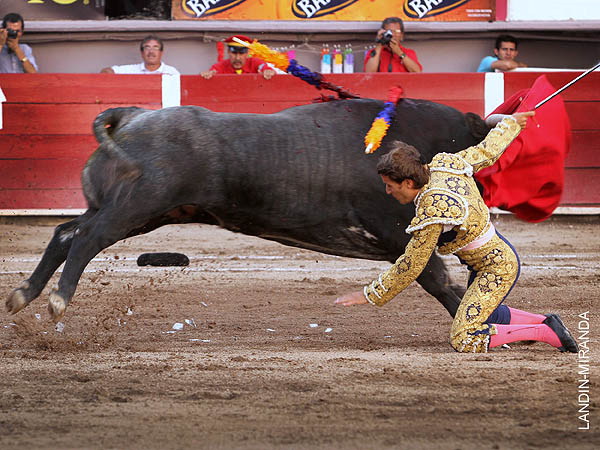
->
[5,209,96,314]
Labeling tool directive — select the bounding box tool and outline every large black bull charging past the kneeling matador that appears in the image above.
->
[6,99,487,320]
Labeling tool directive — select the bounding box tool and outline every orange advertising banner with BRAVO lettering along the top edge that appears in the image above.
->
[172,0,496,22]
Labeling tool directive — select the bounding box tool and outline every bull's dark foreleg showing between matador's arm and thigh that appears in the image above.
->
[417,253,465,317]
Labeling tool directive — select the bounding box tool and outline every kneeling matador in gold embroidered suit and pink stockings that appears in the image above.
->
[336,112,578,353]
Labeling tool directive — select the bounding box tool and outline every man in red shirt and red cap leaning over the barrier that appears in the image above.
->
[200,34,275,80]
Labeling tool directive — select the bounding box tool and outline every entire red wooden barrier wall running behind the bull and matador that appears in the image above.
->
[0,72,600,214]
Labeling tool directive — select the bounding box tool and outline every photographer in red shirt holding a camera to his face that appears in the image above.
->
[364,17,423,72]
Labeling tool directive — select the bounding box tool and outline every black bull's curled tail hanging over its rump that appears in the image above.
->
[93,107,145,179]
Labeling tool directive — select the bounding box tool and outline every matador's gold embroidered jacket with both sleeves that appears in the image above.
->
[363,116,521,306]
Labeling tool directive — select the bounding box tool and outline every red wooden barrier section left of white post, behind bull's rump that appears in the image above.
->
[0,74,161,214]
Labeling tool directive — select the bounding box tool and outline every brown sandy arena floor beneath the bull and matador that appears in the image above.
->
[0,216,600,450]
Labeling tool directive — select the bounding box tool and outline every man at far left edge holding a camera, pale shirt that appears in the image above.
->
[0,13,38,73]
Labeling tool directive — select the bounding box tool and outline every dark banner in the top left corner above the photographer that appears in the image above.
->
[0,0,106,20]
